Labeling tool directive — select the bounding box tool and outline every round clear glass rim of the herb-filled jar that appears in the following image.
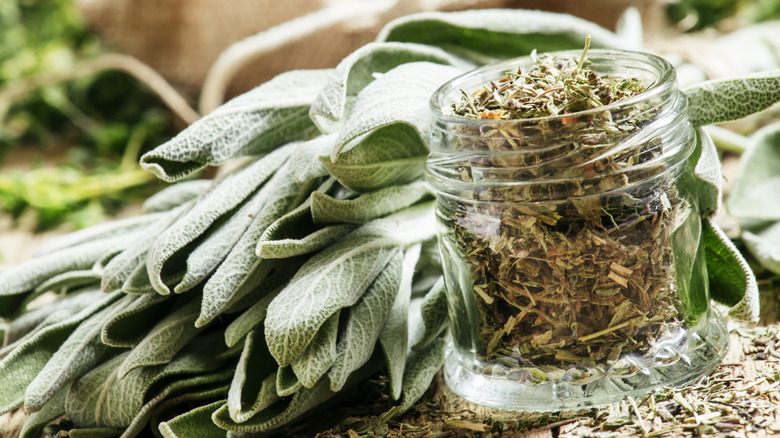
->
[430,49,676,127]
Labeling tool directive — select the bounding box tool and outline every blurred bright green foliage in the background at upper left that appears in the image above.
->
[0,0,176,228]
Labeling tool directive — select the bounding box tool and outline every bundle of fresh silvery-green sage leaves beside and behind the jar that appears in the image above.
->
[0,10,768,438]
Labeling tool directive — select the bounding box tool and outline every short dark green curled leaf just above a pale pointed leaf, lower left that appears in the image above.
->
[100,294,174,347]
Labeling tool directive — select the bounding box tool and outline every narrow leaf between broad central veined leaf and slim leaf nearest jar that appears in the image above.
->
[328,253,403,392]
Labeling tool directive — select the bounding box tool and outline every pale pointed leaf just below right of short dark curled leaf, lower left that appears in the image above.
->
[118,299,203,379]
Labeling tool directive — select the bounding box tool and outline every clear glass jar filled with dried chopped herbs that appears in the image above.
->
[426,50,728,411]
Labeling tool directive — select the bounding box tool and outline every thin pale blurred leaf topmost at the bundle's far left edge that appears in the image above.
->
[35,213,165,257]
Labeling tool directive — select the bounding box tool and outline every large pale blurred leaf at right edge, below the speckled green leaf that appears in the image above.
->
[726,124,780,220]
